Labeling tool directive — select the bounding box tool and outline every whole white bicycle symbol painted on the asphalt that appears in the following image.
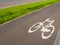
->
[28,18,55,39]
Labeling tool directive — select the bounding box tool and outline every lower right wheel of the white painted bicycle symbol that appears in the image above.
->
[41,25,55,39]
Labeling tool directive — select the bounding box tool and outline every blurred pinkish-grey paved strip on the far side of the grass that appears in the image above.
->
[0,0,42,8]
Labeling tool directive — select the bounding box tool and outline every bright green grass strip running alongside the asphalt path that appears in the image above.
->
[0,0,57,24]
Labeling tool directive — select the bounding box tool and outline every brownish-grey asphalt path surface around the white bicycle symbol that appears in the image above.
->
[0,3,60,45]
